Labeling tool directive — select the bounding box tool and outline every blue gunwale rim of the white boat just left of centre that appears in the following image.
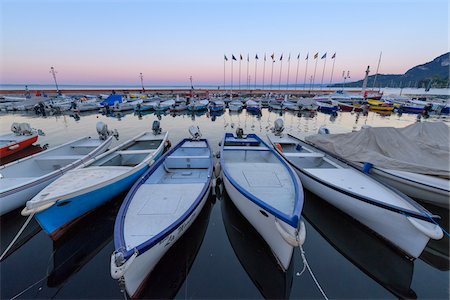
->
[114,139,213,259]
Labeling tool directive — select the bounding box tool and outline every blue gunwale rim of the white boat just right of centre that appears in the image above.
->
[220,133,303,228]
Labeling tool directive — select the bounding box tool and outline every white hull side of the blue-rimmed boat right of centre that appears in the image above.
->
[222,174,296,271]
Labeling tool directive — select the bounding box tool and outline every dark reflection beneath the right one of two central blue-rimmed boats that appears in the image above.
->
[221,193,294,299]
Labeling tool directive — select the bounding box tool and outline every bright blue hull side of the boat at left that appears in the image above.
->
[35,165,148,240]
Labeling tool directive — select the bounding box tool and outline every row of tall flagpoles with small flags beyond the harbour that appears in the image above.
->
[223,52,336,90]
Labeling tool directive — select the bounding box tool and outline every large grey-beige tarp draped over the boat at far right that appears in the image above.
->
[306,122,450,178]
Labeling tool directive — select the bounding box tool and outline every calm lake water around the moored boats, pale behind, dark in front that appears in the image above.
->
[0,110,450,299]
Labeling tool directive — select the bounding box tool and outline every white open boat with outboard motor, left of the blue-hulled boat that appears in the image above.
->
[0,122,113,215]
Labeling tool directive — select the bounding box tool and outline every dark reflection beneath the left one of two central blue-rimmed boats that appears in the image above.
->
[139,199,213,299]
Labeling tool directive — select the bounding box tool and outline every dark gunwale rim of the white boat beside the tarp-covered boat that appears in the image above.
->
[276,134,441,224]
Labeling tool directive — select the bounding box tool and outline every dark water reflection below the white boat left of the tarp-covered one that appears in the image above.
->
[303,192,417,299]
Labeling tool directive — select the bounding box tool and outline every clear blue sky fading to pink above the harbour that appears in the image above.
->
[0,0,448,86]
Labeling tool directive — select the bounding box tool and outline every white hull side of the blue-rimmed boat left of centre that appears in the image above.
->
[124,188,210,298]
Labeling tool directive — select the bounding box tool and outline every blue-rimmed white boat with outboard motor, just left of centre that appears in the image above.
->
[111,126,213,297]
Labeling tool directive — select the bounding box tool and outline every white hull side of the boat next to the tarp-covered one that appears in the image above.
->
[296,168,430,258]
